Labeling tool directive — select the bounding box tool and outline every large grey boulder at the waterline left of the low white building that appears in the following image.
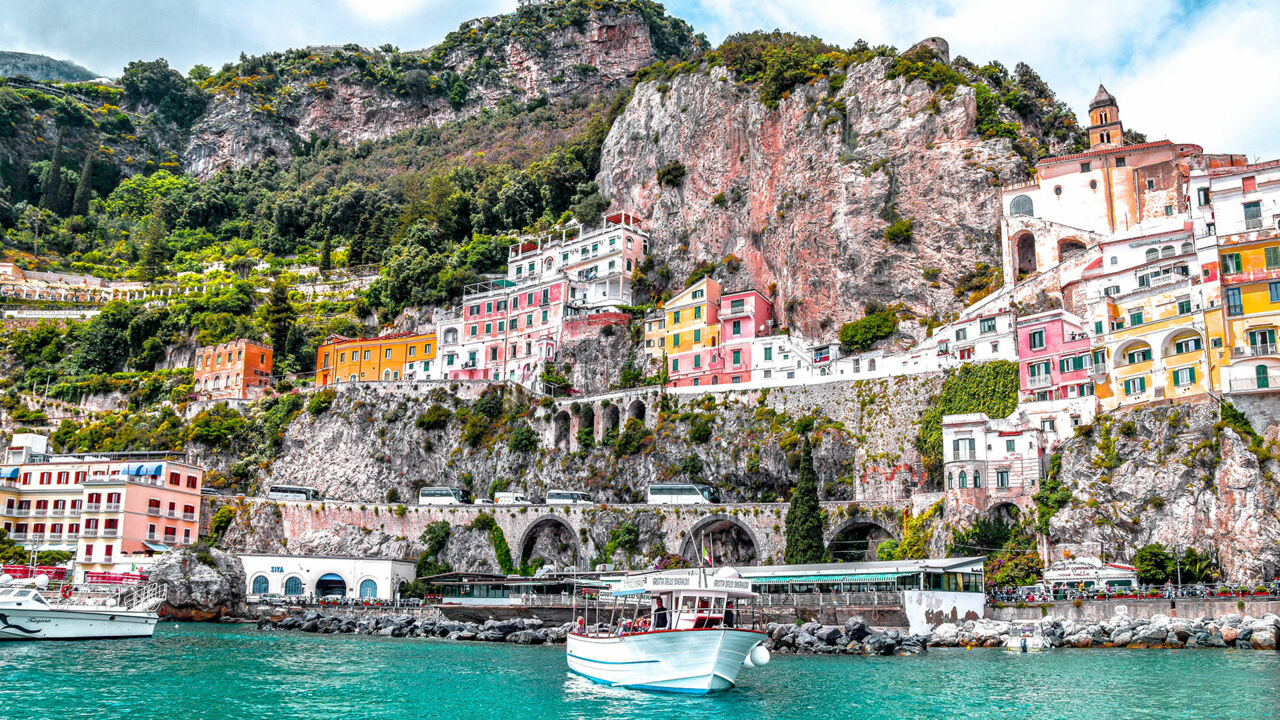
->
[150,547,248,621]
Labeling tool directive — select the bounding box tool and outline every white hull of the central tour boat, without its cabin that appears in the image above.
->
[566,628,765,694]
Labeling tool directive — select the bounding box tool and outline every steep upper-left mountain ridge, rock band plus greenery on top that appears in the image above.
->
[182,0,703,177]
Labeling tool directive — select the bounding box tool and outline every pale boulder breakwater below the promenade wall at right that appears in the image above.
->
[928,612,1280,650]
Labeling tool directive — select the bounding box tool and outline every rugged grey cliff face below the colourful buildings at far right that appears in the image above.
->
[1050,405,1280,580]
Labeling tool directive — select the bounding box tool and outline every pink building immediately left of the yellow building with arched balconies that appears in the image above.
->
[1018,310,1093,402]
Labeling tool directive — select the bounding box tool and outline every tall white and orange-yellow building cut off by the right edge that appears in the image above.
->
[1190,160,1280,396]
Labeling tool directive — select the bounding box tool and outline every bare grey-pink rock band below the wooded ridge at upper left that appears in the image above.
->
[182,9,686,178]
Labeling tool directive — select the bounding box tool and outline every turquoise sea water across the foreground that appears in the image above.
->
[0,624,1280,720]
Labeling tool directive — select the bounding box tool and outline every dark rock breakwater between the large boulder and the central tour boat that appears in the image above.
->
[257,610,573,644]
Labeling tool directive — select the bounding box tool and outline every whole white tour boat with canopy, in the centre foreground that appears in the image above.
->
[566,568,769,694]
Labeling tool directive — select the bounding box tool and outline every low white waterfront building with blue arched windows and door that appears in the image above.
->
[239,555,415,600]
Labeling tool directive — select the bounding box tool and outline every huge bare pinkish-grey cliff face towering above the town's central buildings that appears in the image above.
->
[598,58,1023,337]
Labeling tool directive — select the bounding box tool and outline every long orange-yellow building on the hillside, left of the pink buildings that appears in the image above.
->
[316,333,439,386]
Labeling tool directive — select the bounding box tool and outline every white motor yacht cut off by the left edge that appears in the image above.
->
[0,577,164,641]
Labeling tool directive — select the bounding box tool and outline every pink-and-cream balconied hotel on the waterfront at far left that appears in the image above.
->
[0,434,204,573]
